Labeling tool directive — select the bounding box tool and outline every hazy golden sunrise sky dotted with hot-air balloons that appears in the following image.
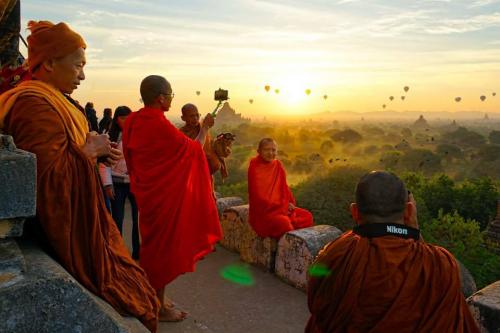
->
[21,0,500,118]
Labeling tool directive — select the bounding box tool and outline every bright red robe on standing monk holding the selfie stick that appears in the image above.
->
[123,107,222,290]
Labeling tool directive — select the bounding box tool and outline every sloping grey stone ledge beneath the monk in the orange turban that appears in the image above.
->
[0,243,148,333]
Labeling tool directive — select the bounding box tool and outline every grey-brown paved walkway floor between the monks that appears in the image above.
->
[124,201,309,333]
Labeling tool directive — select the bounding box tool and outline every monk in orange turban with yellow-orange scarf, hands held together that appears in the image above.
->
[0,21,159,332]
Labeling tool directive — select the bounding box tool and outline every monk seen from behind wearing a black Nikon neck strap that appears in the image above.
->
[306,171,479,333]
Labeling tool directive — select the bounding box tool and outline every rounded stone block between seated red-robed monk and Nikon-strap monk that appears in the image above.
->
[275,225,342,291]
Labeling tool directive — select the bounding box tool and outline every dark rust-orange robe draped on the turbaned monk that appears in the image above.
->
[0,81,159,331]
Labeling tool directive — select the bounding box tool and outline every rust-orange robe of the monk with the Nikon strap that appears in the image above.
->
[306,231,479,333]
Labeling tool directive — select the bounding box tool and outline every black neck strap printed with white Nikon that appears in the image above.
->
[352,223,420,240]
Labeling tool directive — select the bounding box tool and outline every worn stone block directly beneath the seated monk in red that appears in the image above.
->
[220,205,277,272]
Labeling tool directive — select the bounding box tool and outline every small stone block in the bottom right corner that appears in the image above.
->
[467,281,500,333]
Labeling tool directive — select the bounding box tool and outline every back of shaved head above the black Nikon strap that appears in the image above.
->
[356,171,408,218]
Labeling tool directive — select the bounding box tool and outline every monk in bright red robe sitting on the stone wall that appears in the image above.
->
[248,138,313,238]
